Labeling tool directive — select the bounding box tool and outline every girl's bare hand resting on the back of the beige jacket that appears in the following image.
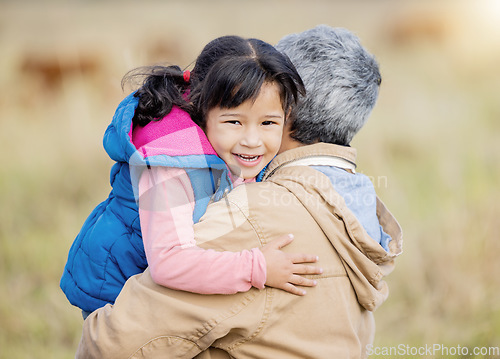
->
[261,234,323,295]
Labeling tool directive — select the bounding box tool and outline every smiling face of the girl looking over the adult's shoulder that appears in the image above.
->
[205,82,285,179]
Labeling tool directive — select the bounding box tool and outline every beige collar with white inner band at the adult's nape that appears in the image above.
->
[263,142,356,180]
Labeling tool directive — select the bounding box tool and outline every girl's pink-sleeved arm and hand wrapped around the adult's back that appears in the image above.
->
[139,167,315,294]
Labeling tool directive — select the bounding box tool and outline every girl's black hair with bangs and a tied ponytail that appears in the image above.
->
[124,36,305,128]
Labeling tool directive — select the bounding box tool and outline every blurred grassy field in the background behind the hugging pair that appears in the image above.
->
[0,0,500,358]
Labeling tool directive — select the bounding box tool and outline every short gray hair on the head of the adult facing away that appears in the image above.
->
[276,25,381,145]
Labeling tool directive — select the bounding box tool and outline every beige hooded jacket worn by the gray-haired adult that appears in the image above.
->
[77,144,402,359]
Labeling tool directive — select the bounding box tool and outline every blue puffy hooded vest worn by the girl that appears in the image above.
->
[60,94,231,312]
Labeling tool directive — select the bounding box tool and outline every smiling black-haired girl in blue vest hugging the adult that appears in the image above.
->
[61,36,319,312]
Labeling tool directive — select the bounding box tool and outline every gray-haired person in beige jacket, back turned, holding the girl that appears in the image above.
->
[77,26,402,358]
